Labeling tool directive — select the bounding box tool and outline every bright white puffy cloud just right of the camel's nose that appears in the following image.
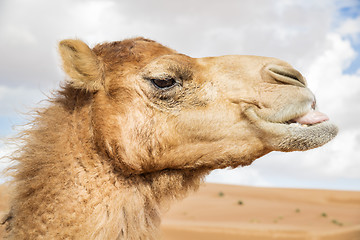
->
[305,33,360,115]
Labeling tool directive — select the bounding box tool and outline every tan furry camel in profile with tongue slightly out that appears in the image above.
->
[3,38,338,240]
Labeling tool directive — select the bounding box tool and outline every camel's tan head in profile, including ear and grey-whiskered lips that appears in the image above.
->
[59,38,337,174]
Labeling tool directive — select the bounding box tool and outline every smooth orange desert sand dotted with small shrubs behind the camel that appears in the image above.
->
[0,183,360,240]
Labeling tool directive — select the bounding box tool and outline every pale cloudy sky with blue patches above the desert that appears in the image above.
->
[0,0,360,191]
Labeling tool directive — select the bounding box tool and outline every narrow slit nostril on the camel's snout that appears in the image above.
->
[267,64,306,87]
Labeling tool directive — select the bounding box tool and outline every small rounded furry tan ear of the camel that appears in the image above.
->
[59,39,104,91]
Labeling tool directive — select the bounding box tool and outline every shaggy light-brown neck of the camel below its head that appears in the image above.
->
[5,94,207,239]
